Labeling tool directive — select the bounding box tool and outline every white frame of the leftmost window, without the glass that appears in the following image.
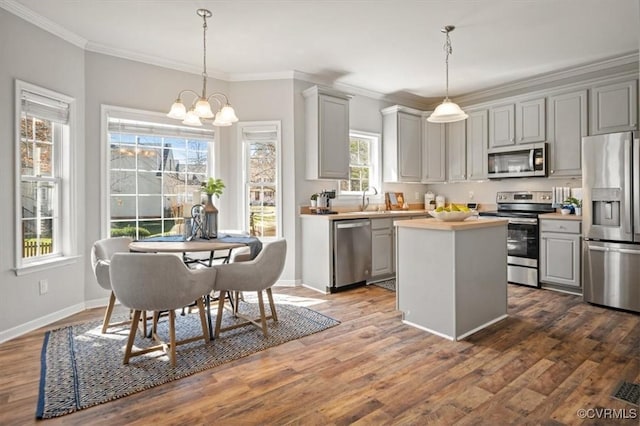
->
[14,79,79,276]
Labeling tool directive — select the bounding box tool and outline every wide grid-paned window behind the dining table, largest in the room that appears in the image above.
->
[106,109,214,239]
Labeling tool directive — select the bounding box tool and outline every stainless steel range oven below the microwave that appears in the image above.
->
[481,191,555,287]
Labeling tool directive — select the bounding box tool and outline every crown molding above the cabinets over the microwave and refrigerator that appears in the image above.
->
[454,51,640,105]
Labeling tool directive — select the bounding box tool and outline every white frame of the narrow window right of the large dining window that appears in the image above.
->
[237,120,283,241]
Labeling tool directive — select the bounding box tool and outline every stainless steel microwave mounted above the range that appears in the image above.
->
[488,142,547,179]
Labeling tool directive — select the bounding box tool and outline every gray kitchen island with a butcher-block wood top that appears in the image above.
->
[394,218,507,340]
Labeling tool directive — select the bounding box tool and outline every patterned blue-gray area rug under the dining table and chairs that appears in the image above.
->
[36,295,340,419]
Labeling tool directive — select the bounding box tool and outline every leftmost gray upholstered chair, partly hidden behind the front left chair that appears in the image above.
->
[91,237,132,334]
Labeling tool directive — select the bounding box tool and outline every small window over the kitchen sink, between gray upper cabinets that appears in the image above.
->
[340,132,380,196]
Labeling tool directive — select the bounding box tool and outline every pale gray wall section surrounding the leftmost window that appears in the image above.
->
[0,9,86,341]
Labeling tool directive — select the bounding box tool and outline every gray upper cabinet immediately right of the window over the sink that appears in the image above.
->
[382,105,422,182]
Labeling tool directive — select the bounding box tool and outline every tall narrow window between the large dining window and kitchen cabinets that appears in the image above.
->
[238,122,281,238]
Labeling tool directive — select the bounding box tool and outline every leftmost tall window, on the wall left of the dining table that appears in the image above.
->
[16,80,75,274]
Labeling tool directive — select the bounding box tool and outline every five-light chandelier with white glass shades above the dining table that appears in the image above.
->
[167,9,238,126]
